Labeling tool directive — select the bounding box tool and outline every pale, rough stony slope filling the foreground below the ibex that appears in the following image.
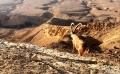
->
[0,40,120,74]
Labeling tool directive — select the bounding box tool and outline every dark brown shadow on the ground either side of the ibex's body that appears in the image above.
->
[46,35,102,54]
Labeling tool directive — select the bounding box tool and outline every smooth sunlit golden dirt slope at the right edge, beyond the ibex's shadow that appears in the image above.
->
[101,26,120,49]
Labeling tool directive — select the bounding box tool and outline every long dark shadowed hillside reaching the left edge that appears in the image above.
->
[0,12,53,29]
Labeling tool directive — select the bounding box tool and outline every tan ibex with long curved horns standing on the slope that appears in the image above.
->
[70,23,87,56]
